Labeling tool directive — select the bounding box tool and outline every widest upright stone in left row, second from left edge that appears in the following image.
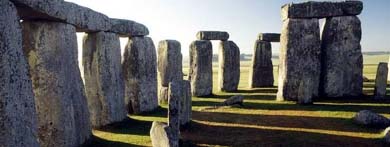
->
[22,21,92,147]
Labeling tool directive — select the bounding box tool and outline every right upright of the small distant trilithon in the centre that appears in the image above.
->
[218,41,240,92]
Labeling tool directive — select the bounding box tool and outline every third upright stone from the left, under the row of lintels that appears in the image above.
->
[83,32,127,127]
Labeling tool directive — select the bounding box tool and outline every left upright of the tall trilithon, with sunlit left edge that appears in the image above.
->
[277,19,321,101]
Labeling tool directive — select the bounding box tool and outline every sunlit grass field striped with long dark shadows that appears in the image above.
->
[90,55,390,147]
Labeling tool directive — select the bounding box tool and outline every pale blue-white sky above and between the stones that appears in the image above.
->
[66,0,390,56]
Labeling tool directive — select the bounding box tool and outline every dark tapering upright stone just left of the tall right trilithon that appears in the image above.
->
[249,40,274,88]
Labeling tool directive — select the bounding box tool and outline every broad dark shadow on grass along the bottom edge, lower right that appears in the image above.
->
[181,123,384,147]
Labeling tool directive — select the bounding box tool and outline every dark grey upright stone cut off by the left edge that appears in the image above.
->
[0,0,39,147]
